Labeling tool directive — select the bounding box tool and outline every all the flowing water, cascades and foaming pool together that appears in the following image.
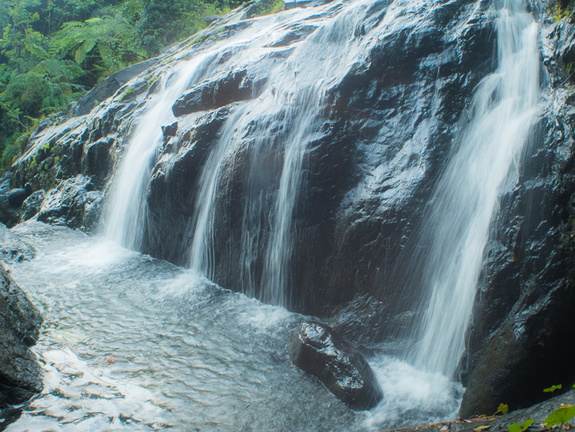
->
[3,0,539,426]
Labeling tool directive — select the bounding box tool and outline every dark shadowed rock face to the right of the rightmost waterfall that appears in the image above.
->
[460,15,575,417]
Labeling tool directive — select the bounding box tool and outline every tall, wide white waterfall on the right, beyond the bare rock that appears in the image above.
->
[411,0,539,378]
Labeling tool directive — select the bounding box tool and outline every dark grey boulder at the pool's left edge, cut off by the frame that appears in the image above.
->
[0,266,42,408]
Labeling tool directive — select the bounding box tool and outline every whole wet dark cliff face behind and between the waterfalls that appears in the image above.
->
[4,0,575,415]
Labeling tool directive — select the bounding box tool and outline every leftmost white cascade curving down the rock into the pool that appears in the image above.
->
[102,23,288,250]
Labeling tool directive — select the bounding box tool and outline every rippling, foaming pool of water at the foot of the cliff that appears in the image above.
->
[4,223,461,432]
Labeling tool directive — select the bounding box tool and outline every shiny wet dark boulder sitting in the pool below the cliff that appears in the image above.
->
[288,323,383,410]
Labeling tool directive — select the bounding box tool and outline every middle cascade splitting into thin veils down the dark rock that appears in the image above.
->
[190,1,394,306]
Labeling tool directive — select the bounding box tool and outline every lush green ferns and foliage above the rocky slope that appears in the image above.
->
[0,0,242,166]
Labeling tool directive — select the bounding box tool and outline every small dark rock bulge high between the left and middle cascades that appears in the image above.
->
[172,70,266,117]
